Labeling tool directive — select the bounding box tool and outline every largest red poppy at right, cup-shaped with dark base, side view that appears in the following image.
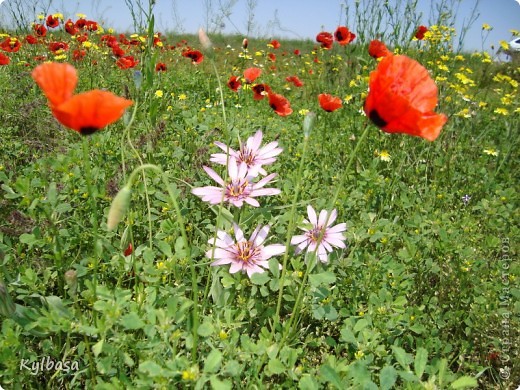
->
[364,55,448,141]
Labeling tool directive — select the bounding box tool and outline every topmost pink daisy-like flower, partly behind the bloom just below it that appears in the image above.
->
[210,130,283,177]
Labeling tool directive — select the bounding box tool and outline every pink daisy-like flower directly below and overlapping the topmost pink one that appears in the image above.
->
[191,157,281,207]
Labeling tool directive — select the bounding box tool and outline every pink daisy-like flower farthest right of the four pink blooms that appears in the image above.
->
[291,206,347,263]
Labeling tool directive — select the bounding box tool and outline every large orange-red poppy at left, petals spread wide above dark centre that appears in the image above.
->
[32,62,132,135]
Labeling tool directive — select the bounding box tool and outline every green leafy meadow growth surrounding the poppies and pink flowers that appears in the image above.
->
[0,16,520,389]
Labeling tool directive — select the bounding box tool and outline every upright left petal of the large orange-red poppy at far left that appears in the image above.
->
[32,62,78,107]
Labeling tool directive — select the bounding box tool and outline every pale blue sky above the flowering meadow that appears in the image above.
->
[0,0,520,51]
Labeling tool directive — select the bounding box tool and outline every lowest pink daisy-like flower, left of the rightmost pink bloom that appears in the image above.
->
[206,223,285,277]
